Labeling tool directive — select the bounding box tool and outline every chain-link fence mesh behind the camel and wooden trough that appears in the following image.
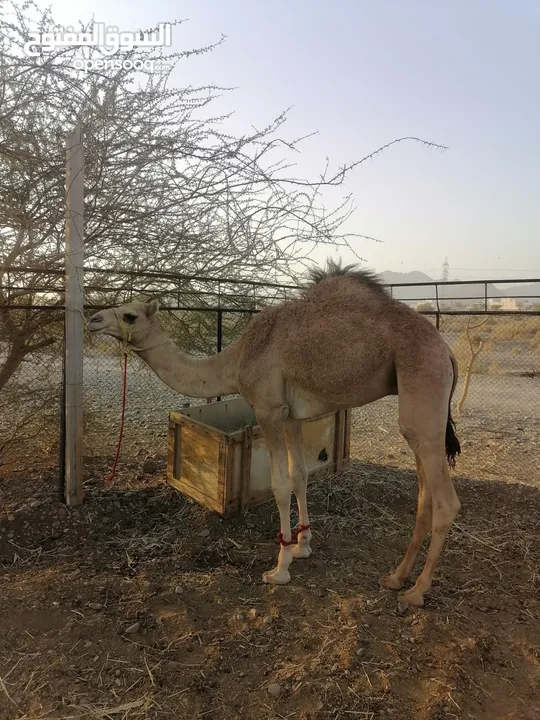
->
[0,270,540,496]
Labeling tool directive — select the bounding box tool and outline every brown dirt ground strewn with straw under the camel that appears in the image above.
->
[0,408,540,720]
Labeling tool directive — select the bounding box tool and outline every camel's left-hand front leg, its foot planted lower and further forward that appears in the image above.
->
[256,408,293,585]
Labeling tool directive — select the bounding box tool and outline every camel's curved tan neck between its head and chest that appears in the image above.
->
[132,323,240,398]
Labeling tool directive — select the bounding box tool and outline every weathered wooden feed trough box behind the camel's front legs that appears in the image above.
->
[167,398,350,515]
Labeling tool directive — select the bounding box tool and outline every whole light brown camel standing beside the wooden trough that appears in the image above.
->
[88,260,461,607]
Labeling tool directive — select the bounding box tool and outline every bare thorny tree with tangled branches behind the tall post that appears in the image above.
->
[0,0,441,404]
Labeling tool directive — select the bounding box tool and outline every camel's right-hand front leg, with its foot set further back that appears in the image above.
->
[285,419,311,558]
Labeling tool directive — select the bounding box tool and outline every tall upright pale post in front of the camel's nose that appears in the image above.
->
[64,124,84,505]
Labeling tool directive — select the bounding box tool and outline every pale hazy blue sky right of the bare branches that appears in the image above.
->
[44,0,540,279]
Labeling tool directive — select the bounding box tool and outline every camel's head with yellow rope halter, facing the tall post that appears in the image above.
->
[88,300,159,342]
